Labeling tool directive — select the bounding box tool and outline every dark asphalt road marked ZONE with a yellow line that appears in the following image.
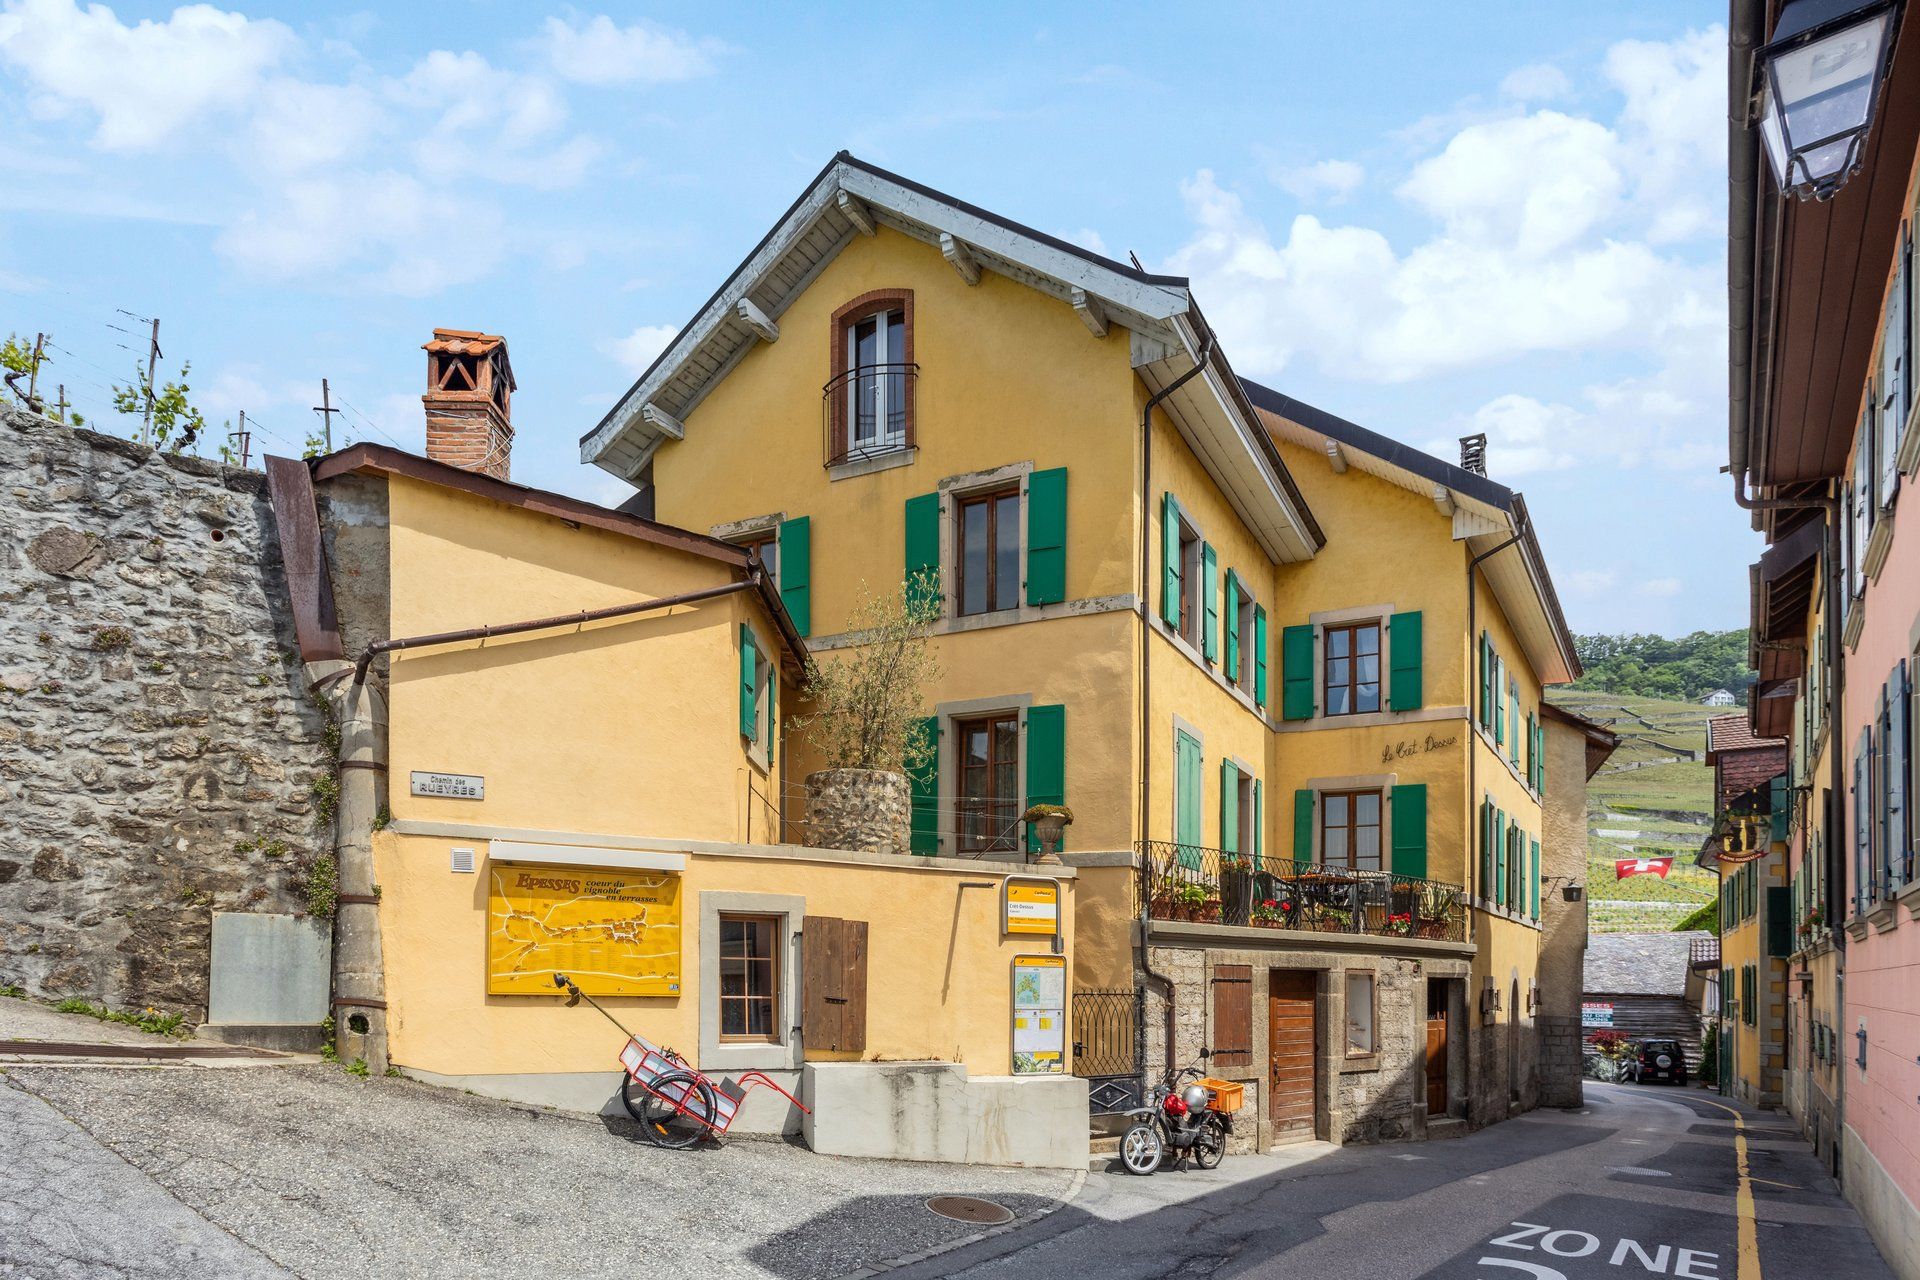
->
[887,1084,1893,1280]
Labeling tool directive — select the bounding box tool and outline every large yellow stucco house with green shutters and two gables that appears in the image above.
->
[582,154,1584,1142]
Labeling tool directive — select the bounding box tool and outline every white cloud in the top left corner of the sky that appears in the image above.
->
[0,0,296,152]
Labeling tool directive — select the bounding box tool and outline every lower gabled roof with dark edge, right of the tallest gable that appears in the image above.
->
[1240,378,1580,685]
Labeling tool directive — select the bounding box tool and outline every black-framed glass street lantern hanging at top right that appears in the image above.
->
[1759,0,1899,200]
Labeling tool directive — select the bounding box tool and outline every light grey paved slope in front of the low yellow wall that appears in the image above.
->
[0,1059,1077,1280]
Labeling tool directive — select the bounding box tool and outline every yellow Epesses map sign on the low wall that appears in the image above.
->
[486,862,680,996]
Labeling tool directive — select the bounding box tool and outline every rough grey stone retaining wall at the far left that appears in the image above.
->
[0,407,332,1021]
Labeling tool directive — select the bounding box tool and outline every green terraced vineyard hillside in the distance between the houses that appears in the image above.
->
[1548,689,1732,933]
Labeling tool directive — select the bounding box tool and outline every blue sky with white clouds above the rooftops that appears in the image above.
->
[0,0,1759,633]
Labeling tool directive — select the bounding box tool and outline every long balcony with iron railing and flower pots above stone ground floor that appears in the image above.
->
[1135,841,1467,942]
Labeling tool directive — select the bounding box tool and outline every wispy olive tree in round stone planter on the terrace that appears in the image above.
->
[791,578,941,854]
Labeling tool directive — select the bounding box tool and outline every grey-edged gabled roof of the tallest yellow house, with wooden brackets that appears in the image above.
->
[580,152,1323,562]
